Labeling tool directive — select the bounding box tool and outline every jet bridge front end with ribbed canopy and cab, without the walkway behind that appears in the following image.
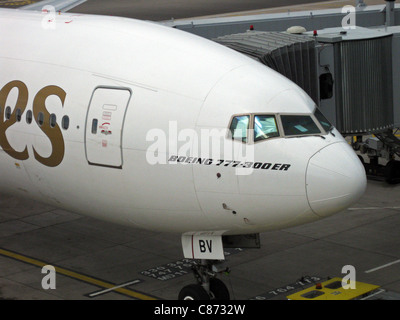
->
[214,26,400,182]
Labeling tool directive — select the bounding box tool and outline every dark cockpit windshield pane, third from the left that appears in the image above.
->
[281,115,321,136]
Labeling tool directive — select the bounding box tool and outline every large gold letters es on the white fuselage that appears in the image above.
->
[0,80,66,167]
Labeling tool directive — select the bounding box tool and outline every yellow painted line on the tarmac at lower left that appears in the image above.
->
[0,248,157,300]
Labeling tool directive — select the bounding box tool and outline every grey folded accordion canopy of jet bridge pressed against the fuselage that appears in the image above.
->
[214,31,318,103]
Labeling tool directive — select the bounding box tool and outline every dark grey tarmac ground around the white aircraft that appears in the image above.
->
[0,0,400,300]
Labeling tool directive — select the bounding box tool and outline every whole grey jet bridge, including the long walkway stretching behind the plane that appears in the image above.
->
[164,0,400,183]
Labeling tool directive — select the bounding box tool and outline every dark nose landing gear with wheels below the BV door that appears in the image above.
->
[178,259,230,300]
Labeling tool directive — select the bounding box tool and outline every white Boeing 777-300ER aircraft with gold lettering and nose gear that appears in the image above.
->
[0,9,366,299]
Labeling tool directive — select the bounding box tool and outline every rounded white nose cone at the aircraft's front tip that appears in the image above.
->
[306,143,367,217]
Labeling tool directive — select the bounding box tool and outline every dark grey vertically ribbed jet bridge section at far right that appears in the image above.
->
[334,36,394,134]
